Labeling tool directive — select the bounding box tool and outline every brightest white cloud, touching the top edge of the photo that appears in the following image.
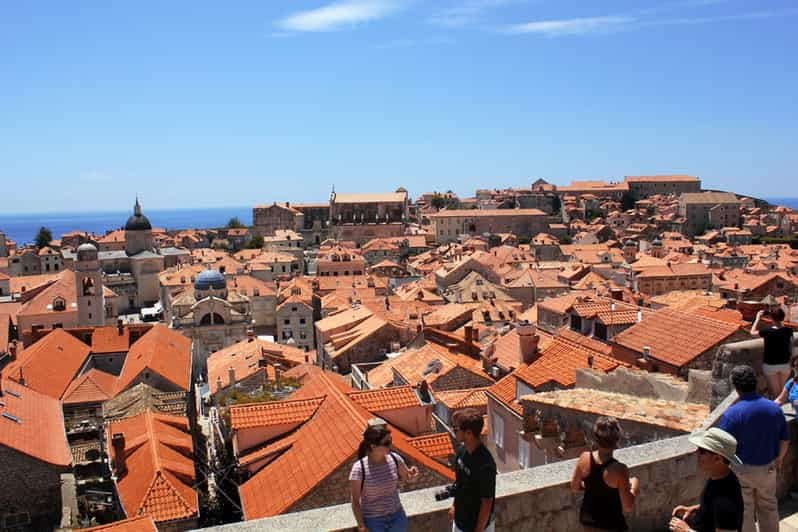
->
[276,0,401,32]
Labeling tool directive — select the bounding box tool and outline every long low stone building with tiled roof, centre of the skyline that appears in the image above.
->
[429,209,549,244]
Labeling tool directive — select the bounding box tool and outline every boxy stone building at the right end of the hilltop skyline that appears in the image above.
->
[679,192,740,237]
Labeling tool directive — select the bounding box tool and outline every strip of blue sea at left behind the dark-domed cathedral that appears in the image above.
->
[0,207,252,244]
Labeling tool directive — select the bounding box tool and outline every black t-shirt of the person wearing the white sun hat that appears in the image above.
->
[690,472,743,532]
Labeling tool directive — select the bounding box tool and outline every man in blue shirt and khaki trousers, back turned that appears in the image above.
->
[718,366,790,532]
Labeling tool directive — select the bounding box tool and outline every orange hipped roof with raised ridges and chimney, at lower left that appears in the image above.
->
[106,411,199,522]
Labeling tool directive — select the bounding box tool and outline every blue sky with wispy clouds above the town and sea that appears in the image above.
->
[0,0,798,212]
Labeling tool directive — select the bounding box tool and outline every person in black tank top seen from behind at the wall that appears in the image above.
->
[571,417,637,532]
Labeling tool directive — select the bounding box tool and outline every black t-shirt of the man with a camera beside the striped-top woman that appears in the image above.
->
[454,445,496,532]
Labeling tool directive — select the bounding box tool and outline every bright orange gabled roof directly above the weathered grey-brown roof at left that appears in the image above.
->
[116,323,191,393]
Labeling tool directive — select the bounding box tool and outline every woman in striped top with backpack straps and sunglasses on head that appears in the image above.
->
[349,419,418,532]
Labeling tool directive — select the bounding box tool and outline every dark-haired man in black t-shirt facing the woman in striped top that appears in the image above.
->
[449,408,496,532]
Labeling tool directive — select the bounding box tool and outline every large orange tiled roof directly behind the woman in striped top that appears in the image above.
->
[239,366,454,519]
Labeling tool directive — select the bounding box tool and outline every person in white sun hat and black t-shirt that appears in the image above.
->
[670,427,743,532]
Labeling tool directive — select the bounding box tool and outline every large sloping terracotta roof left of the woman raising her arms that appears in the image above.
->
[613,308,740,367]
